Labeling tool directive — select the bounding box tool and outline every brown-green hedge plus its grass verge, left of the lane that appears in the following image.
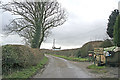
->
[2,45,48,78]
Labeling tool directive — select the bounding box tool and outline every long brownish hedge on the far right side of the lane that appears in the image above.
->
[41,41,102,58]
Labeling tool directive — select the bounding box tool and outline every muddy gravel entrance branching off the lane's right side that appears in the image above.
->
[74,62,118,78]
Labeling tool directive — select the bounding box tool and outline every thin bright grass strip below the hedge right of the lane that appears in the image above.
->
[50,54,89,62]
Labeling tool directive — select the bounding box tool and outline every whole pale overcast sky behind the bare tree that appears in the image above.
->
[0,0,120,49]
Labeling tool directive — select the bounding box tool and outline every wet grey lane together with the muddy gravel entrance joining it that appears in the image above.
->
[33,55,118,78]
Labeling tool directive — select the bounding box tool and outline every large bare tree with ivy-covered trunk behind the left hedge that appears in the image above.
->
[2,0,66,48]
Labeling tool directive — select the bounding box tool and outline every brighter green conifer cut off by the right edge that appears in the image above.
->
[114,15,120,47]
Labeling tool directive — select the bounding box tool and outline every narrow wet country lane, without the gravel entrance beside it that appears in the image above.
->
[34,55,92,78]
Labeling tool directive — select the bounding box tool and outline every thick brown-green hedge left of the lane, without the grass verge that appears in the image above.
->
[2,45,44,75]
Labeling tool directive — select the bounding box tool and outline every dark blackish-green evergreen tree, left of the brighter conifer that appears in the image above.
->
[107,9,119,38]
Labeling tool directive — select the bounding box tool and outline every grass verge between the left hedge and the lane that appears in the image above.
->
[3,57,48,78]
